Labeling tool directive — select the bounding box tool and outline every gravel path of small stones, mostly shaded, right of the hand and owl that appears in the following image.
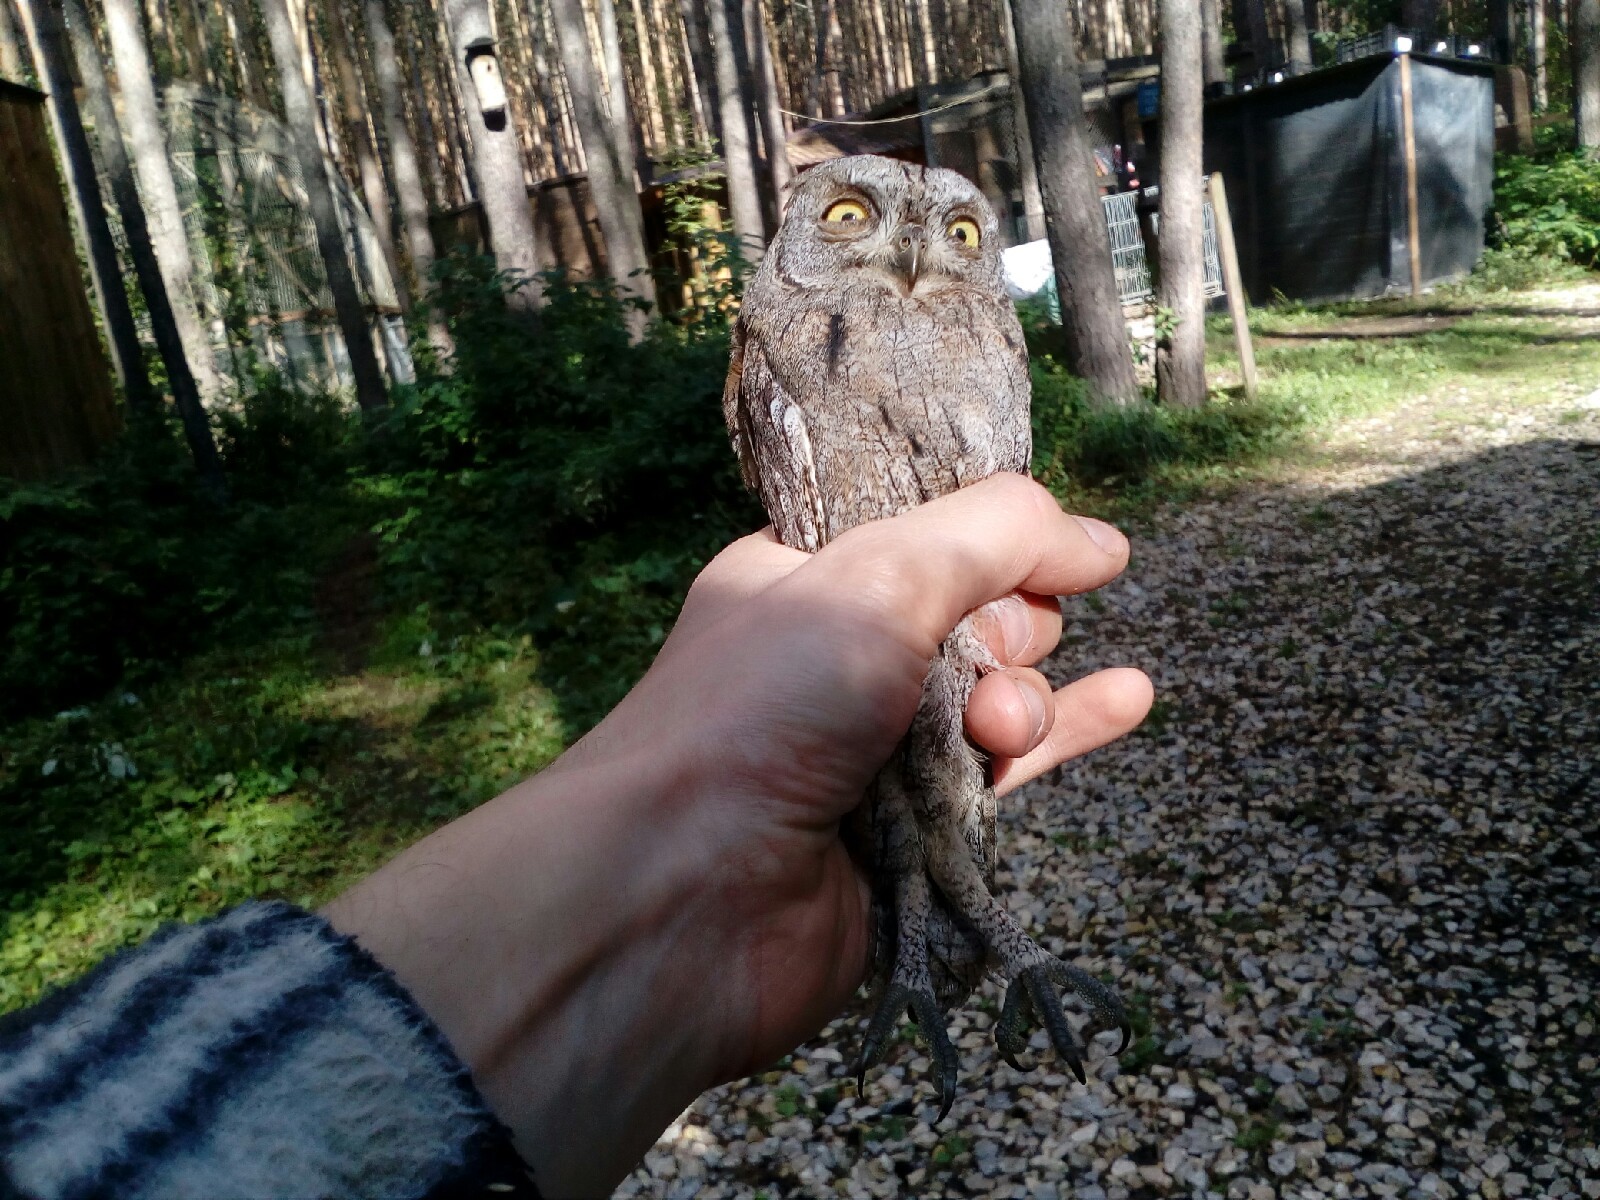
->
[619,316,1600,1200]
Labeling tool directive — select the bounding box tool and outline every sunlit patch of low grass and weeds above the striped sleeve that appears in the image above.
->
[0,620,566,1011]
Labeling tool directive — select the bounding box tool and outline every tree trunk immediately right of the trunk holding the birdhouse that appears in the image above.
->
[550,0,656,329]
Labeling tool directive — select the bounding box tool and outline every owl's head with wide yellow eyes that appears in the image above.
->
[766,154,1000,298]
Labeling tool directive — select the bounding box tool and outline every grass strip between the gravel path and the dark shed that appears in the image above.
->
[1034,273,1600,523]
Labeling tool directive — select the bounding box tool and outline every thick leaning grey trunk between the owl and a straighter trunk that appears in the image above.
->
[1011,0,1139,405]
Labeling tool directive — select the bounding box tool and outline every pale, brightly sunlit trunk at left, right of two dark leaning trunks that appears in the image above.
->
[102,0,221,400]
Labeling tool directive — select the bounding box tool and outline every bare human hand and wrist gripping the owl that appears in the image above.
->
[330,475,1150,1195]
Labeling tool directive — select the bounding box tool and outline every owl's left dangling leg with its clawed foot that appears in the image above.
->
[856,765,957,1120]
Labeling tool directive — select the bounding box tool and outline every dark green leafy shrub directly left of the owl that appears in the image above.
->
[363,258,765,728]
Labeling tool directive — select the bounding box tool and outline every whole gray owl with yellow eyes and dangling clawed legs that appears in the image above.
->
[723,155,1128,1118]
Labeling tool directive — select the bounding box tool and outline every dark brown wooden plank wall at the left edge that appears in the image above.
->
[0,80,117,480]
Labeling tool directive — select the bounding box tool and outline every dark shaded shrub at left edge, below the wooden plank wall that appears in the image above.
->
[0,400,349,720]
